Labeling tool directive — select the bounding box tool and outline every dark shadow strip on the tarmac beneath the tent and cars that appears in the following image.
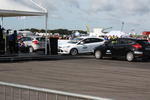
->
[0,53,150,63]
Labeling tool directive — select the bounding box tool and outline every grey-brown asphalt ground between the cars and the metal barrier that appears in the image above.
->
[0,55,150,100]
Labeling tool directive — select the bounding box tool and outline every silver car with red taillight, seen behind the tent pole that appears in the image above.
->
[19,36,45,53]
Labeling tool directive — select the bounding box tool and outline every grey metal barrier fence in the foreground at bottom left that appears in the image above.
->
[0,82,111,100]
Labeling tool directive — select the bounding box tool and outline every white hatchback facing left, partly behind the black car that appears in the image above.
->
[58,37,105,55]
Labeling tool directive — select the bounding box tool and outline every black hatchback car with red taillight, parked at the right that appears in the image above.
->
[94,38,150,61]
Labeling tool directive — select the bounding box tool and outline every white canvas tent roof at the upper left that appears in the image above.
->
[0,0,47,17]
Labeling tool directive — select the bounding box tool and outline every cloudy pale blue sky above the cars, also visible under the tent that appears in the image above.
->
[4,0,150,33]
